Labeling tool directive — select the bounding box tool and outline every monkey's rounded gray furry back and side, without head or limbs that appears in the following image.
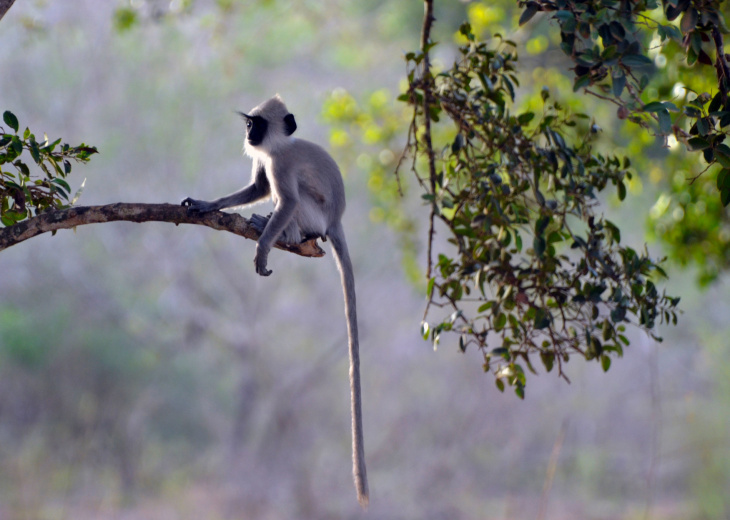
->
[272,138,345,236]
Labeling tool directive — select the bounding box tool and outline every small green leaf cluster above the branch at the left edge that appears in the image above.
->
[0,111,97,226]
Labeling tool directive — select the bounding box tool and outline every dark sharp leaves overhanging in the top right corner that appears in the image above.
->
[520,0,730,206]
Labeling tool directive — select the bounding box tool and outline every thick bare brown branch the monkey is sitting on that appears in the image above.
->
[0,204,325,257]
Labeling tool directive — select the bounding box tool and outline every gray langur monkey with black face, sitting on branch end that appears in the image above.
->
[182,95,368,507]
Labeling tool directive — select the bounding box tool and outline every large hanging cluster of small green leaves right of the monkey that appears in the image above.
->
[400,24,679,397]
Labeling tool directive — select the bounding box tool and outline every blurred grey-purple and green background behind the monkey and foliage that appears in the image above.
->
[0,0,730,520]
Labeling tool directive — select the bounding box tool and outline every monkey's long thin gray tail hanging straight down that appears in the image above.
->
[327,223,370,508]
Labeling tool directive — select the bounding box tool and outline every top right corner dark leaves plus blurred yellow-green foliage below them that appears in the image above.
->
[520,0,730,285]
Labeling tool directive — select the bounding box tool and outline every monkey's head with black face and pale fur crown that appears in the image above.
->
[239,94,297,152]
